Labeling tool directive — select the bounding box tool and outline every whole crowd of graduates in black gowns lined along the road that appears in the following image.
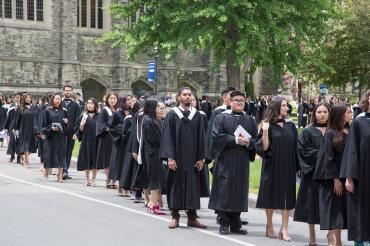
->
[0,85,370,245]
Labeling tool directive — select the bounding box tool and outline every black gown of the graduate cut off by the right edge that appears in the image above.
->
[340,114,370,242]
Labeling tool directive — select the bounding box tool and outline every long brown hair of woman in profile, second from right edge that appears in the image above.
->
[329,102,349,151]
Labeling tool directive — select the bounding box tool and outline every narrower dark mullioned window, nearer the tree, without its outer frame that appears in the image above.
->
[77,0,103,29]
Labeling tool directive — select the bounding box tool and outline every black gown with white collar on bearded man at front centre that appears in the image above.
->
[160,107,205,210]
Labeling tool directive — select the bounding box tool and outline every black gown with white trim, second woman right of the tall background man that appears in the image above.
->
[95,106,113,169]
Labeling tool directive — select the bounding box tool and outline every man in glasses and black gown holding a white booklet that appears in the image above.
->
[209,91,257,235]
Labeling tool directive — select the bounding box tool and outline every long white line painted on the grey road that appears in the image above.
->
[0,173,257,246]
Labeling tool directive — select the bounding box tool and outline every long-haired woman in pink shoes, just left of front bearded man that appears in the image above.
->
[142,99,166,215]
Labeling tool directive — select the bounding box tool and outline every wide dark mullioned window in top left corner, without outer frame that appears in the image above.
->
[0,0,45,21]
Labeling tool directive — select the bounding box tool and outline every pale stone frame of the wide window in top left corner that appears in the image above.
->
[0,0,52,30]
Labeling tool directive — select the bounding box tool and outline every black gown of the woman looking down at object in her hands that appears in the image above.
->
[42,107,68,168]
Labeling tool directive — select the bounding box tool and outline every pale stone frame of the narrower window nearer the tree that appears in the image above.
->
[77,0,107,31]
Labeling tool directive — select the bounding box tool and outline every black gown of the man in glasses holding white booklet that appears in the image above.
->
[208,110,257,212]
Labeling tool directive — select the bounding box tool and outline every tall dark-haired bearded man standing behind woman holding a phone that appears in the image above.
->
[62,85,81,180]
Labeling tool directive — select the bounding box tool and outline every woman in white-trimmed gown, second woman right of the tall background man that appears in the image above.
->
[96,92,118,189]
